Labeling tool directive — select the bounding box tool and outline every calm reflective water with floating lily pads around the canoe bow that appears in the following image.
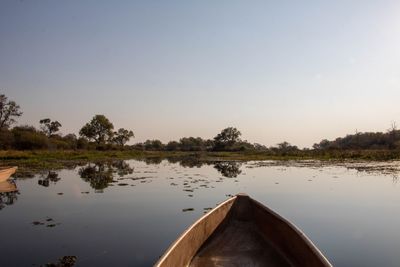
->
[0,160,400,266]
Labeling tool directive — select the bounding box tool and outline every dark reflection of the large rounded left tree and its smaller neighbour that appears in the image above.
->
[78,160,133,193]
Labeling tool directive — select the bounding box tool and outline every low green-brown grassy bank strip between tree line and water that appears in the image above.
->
[0,150,400,168]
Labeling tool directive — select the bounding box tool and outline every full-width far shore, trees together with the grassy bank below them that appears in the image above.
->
[0,94,400,170]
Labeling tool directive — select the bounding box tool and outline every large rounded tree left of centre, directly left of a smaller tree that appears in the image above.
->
[79,115,114,144]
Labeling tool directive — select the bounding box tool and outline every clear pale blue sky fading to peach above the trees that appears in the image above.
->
[0,0,400,147]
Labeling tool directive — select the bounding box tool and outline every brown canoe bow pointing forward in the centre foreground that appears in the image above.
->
[154,194,332,267]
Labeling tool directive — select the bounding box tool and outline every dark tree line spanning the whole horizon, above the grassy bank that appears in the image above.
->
[0,94,400,155]
